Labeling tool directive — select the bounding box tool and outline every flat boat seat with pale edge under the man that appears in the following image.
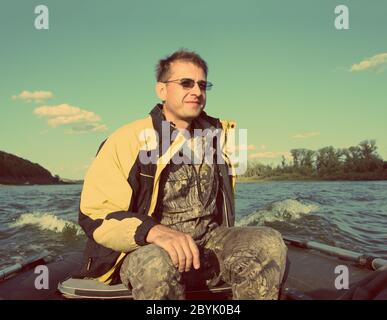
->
[58,278,231,300]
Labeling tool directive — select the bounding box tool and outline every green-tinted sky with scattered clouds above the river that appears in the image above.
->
[0,0,387,179]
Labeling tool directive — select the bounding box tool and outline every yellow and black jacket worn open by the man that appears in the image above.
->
[79,104,236,284]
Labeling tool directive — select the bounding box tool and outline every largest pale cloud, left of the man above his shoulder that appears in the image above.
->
[34,103,107,133]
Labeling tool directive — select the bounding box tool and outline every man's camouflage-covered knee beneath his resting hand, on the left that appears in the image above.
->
[120,244,185,300]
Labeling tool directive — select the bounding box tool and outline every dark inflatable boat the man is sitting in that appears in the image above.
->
[0,238,387,300]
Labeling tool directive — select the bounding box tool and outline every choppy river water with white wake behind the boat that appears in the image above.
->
[0,181,387,269]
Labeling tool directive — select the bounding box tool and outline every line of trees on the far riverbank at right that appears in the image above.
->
[243,140,387,180]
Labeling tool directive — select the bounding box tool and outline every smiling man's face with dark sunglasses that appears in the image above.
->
[164,61,206,120]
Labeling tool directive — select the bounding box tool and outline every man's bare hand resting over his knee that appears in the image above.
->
[146,224,200,272]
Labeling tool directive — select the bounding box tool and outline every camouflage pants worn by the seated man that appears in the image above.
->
[120,227,287,300]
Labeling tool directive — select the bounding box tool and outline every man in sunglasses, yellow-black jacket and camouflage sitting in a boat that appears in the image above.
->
[79,50,286,299]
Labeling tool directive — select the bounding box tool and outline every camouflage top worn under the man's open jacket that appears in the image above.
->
[157,132,219,245]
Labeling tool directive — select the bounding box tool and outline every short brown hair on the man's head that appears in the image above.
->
[156,49,208,82]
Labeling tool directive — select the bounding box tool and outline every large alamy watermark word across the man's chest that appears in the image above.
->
[139,121,247,175]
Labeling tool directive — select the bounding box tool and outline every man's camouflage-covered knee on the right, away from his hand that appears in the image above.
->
[221,227,287,300]
